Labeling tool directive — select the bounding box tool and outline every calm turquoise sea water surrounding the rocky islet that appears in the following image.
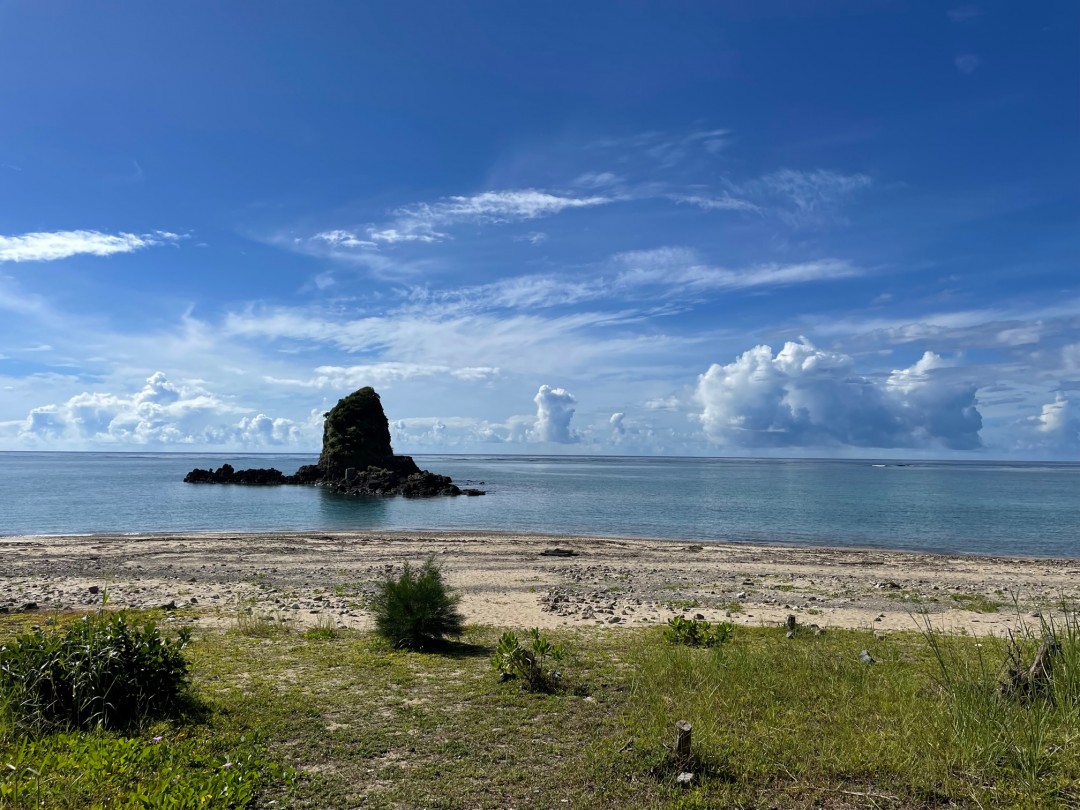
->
[0,453,1080,557]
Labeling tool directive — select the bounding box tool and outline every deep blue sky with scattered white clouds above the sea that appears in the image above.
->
[0,0,1080,460]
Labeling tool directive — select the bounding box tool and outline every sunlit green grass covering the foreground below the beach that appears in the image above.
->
[0,615,1080,810]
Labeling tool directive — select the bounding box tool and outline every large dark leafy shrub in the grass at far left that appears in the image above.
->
[0,612,190,730]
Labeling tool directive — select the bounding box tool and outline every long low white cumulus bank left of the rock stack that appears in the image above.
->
[6,372,320,447]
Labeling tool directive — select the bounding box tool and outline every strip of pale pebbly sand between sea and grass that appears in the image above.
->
[0,532,1080,635]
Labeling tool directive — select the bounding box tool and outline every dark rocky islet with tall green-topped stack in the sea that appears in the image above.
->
[184,388,484,498]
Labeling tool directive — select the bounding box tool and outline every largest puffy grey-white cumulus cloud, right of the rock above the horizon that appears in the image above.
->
[697,338,983,449]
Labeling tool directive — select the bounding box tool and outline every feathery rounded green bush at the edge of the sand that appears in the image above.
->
[372,558,464,649]
